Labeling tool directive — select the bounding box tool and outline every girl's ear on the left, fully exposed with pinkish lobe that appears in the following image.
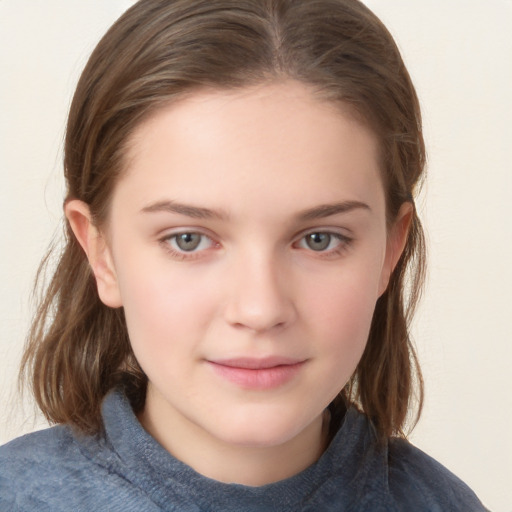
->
[64,199,122,308]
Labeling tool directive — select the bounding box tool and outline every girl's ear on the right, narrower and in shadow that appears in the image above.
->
[379,202,414,296]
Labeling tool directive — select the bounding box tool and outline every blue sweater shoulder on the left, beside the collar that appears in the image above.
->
[0,426,153,512]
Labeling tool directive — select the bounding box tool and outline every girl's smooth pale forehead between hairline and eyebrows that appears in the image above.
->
[114,81,382,218]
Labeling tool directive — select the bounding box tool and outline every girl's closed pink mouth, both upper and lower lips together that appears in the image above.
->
[207,357,306,391]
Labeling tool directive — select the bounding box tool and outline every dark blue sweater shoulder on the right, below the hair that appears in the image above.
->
[388,438,486,512]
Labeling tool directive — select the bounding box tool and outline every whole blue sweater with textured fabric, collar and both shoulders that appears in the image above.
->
[0,392,485,512]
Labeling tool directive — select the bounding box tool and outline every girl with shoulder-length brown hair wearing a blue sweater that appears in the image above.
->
[0,0,485,511]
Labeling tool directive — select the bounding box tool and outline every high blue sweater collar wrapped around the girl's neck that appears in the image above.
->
[89,390,385,511]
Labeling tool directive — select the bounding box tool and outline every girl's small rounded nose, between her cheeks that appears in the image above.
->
[225,253,296,332]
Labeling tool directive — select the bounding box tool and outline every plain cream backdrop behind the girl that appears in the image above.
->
[0,0,512,512]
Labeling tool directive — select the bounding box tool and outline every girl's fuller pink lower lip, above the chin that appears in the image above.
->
[210,362,304,390]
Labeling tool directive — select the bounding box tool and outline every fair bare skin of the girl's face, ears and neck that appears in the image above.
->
[66,81,410,485]
